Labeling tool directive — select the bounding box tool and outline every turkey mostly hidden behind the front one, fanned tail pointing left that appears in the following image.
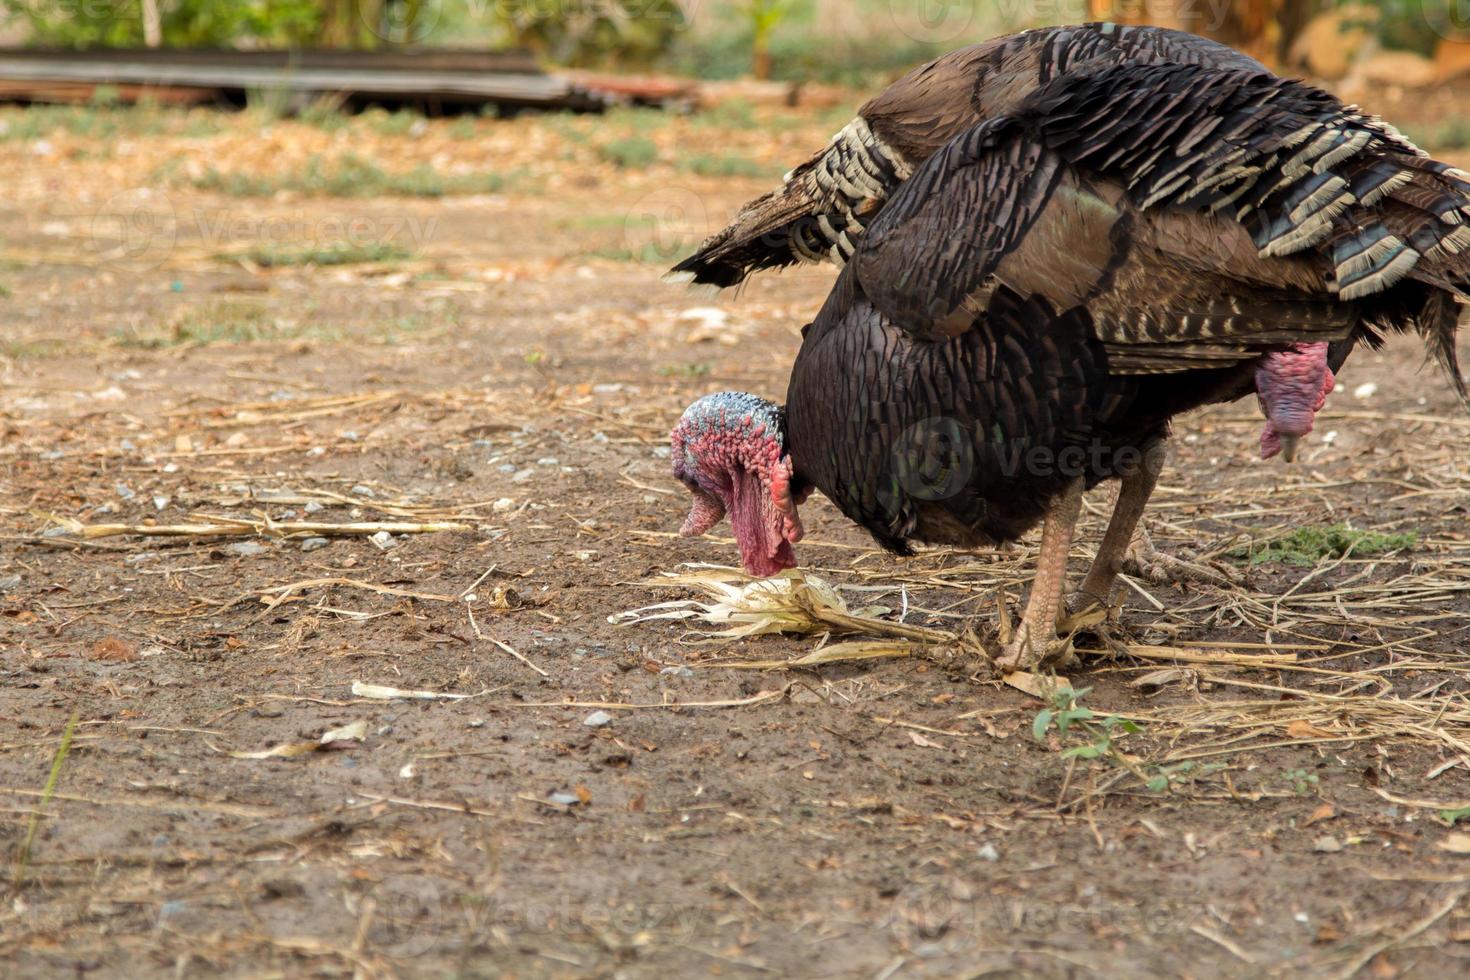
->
[667,24,1351,583]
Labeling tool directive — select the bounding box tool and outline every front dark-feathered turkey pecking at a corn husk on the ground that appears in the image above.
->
[672,63,1470,669]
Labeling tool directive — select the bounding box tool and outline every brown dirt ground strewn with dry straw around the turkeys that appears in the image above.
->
[0,94,1470,979]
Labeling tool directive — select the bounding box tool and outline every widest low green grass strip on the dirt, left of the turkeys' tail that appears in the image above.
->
[191,153,506,197]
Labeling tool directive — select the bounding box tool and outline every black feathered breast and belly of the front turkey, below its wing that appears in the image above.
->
[786,284,1254,554]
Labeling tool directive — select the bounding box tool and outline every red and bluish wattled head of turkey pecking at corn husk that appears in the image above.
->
[670,391,801,576]
